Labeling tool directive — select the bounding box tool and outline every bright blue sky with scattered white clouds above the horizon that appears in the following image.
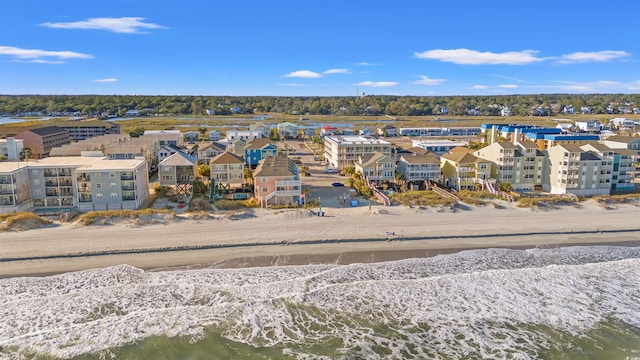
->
[0,0,640,96]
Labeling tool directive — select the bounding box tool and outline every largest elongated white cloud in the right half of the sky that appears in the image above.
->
[414,49,545,65]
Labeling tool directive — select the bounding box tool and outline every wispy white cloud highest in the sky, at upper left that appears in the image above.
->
[40,17,167,34]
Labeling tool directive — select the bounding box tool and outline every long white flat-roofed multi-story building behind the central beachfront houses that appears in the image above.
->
[324,135,393,170]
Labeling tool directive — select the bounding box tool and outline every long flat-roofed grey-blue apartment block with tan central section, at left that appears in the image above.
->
[28,156,149,212]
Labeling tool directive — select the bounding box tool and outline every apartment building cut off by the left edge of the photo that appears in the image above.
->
[0,162,32,214]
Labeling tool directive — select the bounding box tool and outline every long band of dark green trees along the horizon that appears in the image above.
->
[0,94,640,116]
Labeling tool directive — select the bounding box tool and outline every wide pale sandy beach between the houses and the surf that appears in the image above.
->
[0,198,640,277]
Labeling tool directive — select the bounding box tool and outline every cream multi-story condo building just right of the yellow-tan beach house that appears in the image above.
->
[474,141,549,191]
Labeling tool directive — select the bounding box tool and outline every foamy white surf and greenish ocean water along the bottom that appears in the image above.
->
[0,246,640,360]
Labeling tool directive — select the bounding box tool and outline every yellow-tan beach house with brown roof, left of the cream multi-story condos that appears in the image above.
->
[440,148,495,191]
